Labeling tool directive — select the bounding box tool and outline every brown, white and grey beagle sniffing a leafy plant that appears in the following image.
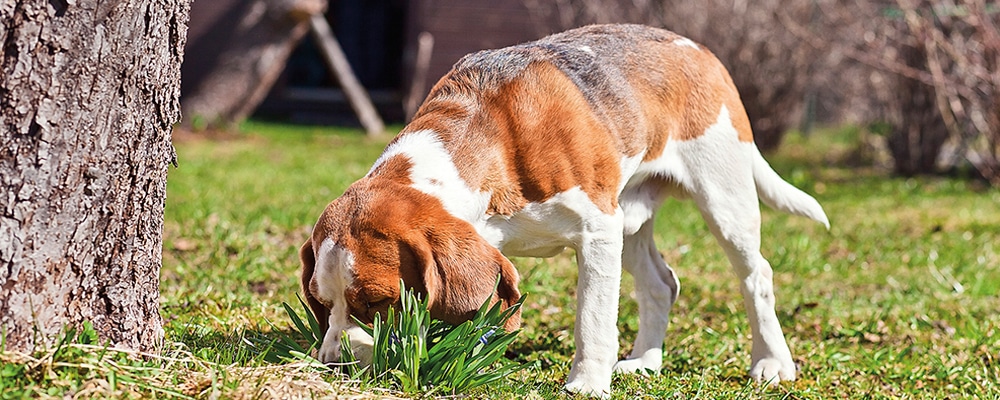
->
[300,25,829,397]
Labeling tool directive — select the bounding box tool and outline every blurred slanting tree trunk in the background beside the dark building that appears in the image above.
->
[176,0,326,128]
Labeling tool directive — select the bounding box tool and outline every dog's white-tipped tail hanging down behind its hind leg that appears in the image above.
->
[753,146,830,229]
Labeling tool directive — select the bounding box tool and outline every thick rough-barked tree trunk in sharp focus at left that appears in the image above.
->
[0,0,189,351]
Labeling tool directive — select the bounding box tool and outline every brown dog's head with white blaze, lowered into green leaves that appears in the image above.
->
[299,178,520,362]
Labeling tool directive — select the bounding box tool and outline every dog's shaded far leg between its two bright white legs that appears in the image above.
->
[615,217,680,373]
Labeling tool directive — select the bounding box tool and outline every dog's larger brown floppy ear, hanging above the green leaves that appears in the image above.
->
[410,221,521,331]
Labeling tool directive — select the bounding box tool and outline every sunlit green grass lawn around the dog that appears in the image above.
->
[0,122,1000,399]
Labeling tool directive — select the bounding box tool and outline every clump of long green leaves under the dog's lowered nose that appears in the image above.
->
[271,281,524,394]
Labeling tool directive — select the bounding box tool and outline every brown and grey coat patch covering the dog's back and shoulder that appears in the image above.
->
[402,25,753,219]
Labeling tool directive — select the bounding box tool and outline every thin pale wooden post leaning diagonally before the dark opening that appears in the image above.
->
[309,14,385,136]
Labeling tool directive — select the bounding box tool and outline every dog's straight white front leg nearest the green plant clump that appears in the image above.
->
[566,210,622,397]
